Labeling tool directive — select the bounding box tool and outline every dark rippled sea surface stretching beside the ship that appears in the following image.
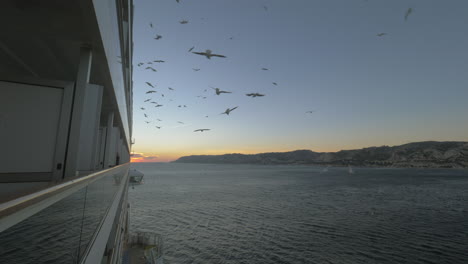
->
[129,163,468,264]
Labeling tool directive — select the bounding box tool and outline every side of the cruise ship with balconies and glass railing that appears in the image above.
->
[0,0,142,264]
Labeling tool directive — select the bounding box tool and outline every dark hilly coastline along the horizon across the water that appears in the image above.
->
[173,141,468,168]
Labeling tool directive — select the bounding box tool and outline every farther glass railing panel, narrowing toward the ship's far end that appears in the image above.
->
[79,166,128,259]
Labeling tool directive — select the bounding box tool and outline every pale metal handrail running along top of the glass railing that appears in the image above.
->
[0,163,130,232]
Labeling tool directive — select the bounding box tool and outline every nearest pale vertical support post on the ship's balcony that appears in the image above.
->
[65,47,93,177]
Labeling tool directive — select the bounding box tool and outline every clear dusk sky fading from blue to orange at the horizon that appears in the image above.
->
[132,0,468,162]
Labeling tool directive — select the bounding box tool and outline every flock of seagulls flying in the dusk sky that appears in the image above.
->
[137,4,413,135]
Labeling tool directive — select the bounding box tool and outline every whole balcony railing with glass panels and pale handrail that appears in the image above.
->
[0,163,129,263]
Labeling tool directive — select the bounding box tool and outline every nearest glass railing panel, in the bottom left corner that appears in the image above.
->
[0,187,86,264]
